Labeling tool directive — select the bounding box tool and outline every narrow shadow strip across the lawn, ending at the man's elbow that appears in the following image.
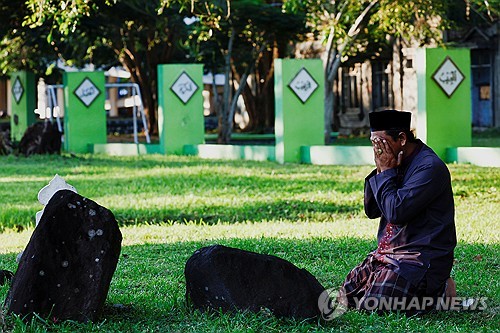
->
[0,200,363,232]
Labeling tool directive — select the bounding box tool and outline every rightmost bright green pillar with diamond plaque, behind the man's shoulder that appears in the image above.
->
[416,48,472,161]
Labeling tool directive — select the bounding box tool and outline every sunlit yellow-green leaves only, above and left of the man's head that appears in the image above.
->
[285,0,447,61]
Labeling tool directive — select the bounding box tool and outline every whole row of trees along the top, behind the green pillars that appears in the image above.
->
[0,0,500,142]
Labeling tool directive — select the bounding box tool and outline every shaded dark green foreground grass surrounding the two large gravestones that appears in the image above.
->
[0,235,499,332]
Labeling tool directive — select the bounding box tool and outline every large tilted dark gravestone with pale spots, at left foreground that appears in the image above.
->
[5,190,122,322]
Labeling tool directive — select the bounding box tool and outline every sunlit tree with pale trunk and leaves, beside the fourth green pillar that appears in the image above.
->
[284,0,500,142]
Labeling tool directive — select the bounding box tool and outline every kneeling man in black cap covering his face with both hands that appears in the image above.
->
[343,110,457,313]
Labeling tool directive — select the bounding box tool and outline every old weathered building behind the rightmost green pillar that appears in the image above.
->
[306,21,500,134]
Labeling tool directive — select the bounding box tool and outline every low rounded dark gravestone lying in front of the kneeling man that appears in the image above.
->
[184,245,324,319]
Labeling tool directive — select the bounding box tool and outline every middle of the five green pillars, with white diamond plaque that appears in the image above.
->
[158,64,205,155]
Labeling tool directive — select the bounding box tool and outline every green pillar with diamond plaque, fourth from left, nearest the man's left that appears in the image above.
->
[274,59,325,163]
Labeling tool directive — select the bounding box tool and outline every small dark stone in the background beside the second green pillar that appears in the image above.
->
[19,121,62,156]
